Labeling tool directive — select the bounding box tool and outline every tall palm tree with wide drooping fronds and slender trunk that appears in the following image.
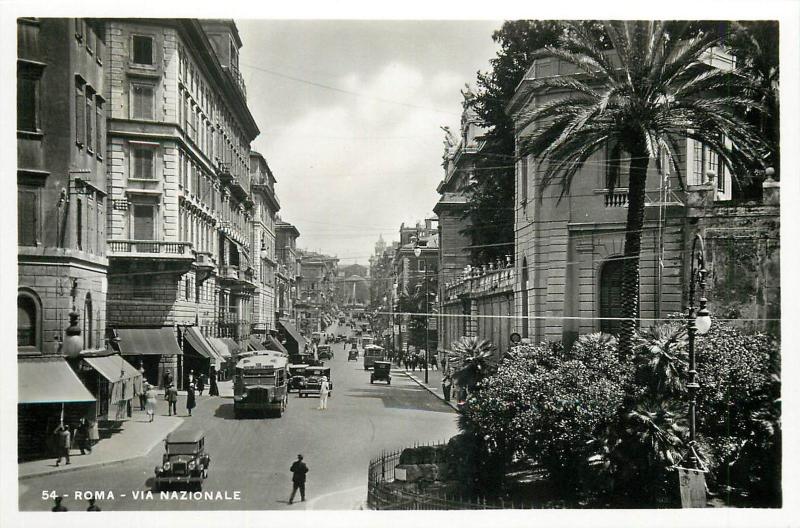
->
[519,21,765,356]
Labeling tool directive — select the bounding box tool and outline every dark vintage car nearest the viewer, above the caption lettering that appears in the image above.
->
[153,429,211,491]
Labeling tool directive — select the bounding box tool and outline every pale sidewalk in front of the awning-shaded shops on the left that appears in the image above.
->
[18,410,183,480]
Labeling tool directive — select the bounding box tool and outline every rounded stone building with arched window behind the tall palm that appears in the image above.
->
[507,53,774,344]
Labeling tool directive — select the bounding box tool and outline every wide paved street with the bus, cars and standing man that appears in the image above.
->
[19,326,457,510]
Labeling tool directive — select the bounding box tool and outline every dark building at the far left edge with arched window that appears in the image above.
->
[17,18,109,355]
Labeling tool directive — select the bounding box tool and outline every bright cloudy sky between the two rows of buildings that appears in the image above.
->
[236,19,502,264]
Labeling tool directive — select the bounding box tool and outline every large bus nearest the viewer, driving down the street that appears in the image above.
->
[233,350,289,418]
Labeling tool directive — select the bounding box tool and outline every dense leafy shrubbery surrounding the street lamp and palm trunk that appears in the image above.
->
[460,320,781,506]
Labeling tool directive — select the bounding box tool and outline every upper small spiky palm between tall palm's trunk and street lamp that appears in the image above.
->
[636,323,688,396]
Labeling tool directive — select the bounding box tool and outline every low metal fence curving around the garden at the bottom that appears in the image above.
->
[367,444,504,510]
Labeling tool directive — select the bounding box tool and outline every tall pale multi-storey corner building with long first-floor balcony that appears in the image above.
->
[105,19,258,383]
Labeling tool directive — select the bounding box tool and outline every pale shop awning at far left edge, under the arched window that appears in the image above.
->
[17,357,96,403]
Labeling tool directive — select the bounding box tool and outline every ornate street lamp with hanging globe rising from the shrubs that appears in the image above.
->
[680,233,711,507]
